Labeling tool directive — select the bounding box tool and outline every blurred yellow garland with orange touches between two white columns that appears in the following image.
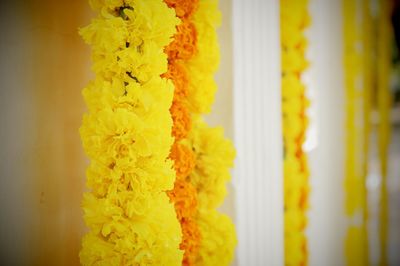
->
[280,0,310,265]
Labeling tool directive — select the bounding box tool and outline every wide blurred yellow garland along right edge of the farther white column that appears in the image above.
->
[343,0,373,265]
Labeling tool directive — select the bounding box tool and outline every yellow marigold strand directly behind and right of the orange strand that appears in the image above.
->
[184,0,237,266]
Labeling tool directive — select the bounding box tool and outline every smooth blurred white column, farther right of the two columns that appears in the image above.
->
[304,0,345,266]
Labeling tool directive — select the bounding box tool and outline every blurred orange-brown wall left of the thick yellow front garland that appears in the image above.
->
[0,0,90,265]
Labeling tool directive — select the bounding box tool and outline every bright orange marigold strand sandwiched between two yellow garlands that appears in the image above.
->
[164,0,201,265]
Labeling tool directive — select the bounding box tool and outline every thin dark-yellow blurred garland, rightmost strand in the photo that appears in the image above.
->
[377,0,393,266]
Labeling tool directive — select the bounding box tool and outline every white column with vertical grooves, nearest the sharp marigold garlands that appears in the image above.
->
[232,0,283,266]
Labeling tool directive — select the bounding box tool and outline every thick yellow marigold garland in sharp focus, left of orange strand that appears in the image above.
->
[80,0,183,265]
